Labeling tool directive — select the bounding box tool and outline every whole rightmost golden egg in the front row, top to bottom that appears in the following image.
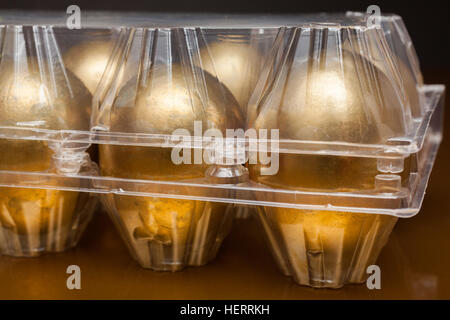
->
[249,55,407,287]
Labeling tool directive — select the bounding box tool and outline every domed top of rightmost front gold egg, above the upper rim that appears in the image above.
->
[250,56,406,143]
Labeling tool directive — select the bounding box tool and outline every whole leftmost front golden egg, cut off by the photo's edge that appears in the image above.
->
[0,58,91,256]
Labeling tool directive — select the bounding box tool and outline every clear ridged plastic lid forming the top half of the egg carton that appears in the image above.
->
[0,12,439,156]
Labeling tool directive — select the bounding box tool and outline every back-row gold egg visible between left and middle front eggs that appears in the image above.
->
[63,41,113,95]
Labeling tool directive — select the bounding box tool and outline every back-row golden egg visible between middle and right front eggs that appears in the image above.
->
[200,40,262,115]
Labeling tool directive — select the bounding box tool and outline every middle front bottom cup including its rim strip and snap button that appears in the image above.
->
[94,162,248,271]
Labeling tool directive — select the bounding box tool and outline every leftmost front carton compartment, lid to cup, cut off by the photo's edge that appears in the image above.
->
[0,24,110,256]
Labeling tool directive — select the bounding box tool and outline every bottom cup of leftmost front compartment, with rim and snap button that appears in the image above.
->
[0,141,98,257]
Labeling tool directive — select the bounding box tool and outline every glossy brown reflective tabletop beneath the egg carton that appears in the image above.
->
[0,71,450,299]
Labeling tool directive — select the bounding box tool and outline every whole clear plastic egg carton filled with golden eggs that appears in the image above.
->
[0,12,445,288]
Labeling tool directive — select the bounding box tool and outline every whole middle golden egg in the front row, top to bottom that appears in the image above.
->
[100,65,243,271]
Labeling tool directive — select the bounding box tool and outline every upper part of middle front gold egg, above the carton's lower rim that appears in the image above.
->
[100,65,243,180]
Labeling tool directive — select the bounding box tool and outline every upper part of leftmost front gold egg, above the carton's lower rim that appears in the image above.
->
[0,65,91,171]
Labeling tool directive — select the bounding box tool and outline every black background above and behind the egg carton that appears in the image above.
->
[0,0,450,70]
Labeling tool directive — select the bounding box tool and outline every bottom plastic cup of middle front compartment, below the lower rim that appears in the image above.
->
[103,194,234,272]
